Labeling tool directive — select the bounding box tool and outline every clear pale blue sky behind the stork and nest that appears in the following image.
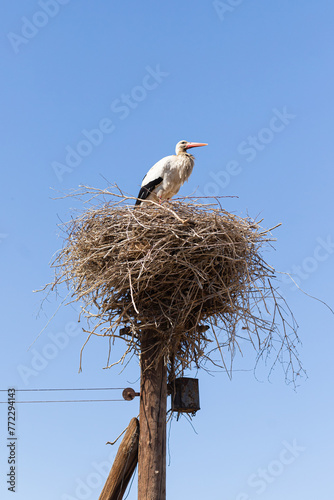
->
[0,0,334,500]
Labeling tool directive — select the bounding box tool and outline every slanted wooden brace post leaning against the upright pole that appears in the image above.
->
[99,418,139,500]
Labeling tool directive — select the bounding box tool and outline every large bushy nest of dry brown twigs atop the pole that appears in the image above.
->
[49,188,300,384]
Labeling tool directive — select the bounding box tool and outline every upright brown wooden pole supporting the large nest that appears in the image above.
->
[138,331,167,500]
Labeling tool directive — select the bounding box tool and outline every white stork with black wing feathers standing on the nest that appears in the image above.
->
[136,141,207,205]
